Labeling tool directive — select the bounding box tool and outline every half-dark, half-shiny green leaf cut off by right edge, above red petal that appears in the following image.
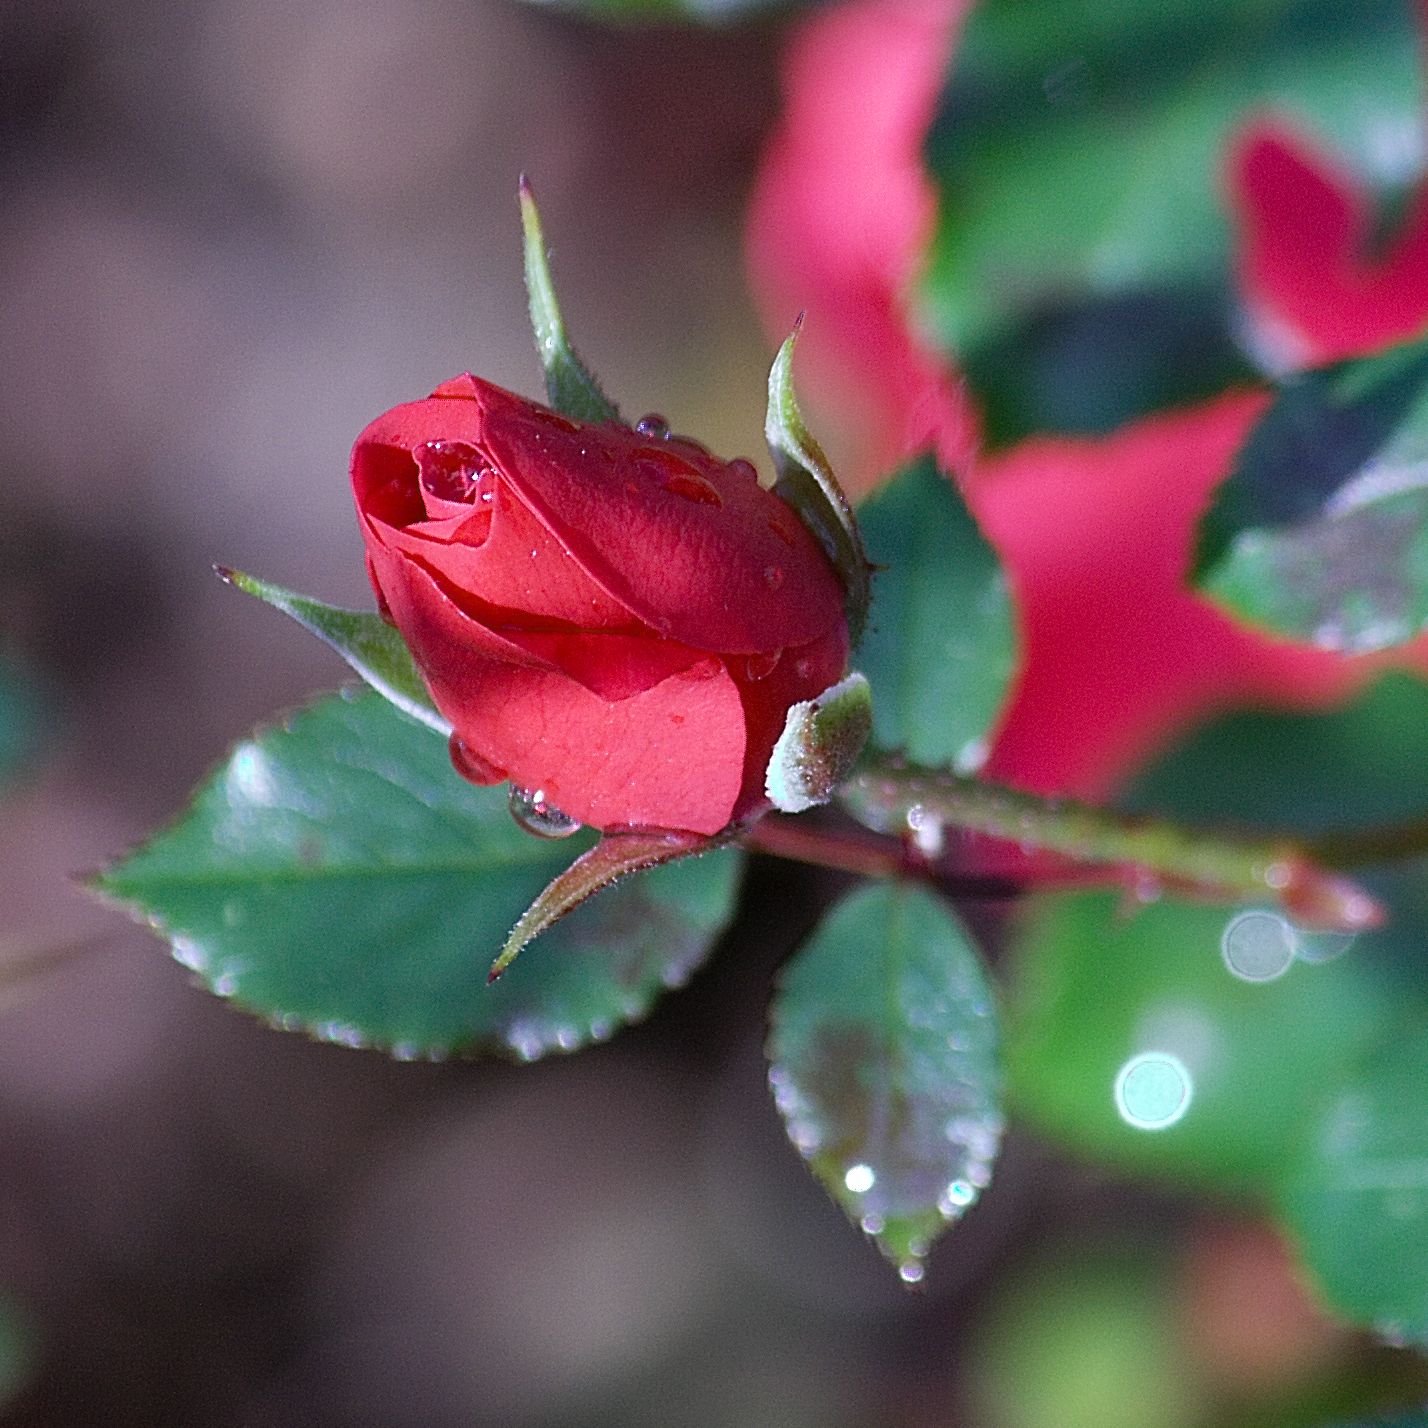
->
[1194,340,1428,654]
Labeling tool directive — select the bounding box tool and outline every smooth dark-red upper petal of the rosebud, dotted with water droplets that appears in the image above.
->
[484,406,843,654]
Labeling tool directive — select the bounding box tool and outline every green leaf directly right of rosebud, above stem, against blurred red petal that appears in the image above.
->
[858,461,1018,773]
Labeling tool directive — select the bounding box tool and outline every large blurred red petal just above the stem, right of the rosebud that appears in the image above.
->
[968,391,1428,798]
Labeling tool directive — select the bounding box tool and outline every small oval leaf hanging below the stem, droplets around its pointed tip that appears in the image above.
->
[768,883,1002,1282]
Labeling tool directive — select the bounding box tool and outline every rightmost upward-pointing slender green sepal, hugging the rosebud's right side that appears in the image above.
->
[764,327,870,645]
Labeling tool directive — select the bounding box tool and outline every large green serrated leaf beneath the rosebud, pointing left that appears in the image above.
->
[96,693,738,1058]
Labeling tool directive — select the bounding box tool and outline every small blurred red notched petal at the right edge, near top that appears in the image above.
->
[1228,123,1428,367]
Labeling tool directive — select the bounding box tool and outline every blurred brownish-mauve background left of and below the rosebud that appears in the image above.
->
[0,0,1370,1428]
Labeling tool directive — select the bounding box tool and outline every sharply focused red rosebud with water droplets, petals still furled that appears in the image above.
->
[351,376,848,834]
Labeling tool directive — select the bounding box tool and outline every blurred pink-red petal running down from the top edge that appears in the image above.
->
[747,0,977,494]
